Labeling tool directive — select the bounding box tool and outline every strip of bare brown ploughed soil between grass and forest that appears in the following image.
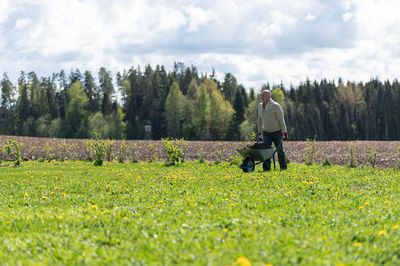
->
[0,135,400,168]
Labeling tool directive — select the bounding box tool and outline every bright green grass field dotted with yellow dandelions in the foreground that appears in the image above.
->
[0,161,400,265]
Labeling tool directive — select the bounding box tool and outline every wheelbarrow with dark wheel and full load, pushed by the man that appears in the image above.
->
[237,139,283,173]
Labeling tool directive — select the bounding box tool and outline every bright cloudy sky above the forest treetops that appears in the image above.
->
[0,0,400,88]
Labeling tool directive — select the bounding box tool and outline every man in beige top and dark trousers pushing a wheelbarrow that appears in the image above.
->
[258,90,289,171]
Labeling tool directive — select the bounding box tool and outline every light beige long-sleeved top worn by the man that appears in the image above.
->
[258,99,287,133]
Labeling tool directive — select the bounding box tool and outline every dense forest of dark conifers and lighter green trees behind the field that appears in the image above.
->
[0,63,400,140]
